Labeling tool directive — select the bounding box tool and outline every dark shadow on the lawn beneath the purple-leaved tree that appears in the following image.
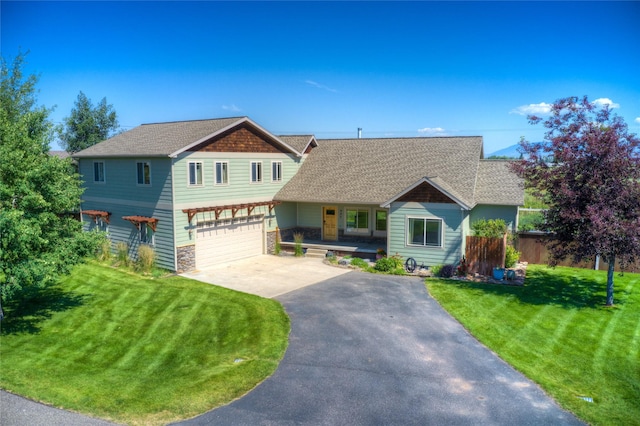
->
[460,269,608,308]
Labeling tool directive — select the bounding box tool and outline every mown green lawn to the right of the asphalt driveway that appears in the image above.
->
[426,265,640,425]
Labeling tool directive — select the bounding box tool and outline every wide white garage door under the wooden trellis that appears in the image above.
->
[196,216,264,269]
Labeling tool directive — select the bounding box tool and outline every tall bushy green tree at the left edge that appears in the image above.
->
[0,54,100,320]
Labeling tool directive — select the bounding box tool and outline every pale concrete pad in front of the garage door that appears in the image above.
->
[181,255,351,298]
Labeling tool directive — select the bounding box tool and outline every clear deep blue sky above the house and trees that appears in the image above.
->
[0,0,640,153]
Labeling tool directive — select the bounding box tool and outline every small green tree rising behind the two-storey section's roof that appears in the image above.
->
[59,92,118,154]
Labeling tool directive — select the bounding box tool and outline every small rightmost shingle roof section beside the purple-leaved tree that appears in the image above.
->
[476,160,524,206]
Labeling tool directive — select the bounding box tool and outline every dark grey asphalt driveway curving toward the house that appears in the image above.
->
[176,272,582,425]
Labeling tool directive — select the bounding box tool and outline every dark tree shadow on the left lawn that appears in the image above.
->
[0,286,87,335]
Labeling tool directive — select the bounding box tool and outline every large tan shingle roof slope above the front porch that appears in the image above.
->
[274,136,482,206]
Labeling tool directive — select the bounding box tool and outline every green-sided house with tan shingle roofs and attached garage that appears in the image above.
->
[74,117,524,271]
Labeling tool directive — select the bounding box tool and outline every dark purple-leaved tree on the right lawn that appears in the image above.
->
[513,96,640,306]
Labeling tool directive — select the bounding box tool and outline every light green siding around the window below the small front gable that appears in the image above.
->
[387,203,466,266]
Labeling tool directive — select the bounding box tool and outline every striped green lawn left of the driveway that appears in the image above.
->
[0,263,289,424]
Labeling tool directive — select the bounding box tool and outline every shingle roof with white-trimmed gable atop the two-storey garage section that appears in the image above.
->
[73,117,302,158]
